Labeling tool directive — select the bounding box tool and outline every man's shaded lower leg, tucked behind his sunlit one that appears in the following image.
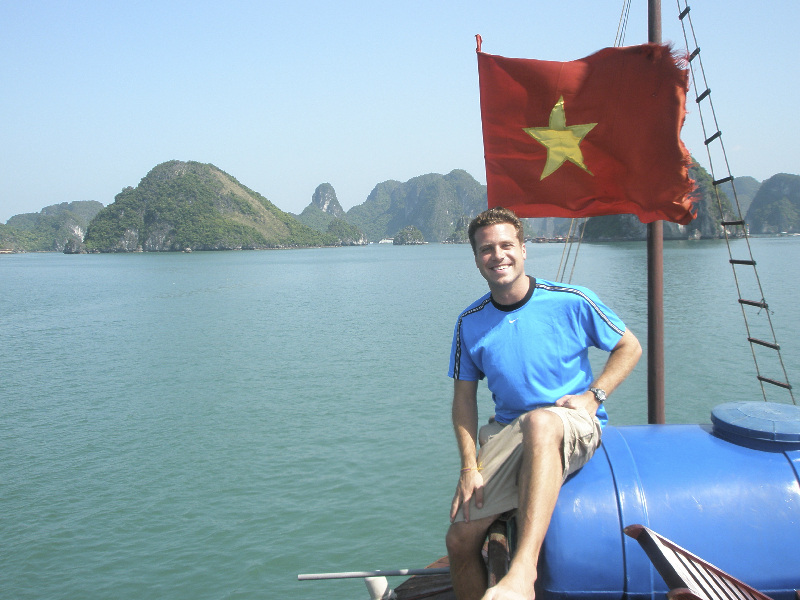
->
[446,515,497,600]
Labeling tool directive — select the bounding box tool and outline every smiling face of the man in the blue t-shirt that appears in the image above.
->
[475,223,526,291]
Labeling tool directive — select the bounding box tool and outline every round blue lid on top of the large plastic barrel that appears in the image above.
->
[711,401,800,443]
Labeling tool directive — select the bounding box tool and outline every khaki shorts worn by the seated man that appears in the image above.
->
[455,406,602,521]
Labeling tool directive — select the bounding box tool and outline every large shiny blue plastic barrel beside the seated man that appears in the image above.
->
[539,402,800,600]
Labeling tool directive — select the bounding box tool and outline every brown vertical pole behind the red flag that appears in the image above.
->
[647,0,666,424]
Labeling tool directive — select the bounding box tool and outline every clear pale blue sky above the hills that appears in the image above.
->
[0,0,800,223]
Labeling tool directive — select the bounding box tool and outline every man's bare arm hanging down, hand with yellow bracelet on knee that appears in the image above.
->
[450,379,483,522]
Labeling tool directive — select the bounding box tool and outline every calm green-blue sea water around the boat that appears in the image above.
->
[0,238,800,600]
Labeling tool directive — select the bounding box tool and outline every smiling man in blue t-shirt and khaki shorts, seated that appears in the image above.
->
[447,208,642,600]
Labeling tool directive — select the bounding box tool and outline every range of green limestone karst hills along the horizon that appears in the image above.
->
[0,160,800,254]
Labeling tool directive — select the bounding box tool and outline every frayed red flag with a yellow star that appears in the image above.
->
[478,39,694,225]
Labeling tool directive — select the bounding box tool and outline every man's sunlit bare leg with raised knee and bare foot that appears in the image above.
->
[482,410,564,600]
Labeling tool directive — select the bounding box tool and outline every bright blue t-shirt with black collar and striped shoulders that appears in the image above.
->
[448,278,625,425]
